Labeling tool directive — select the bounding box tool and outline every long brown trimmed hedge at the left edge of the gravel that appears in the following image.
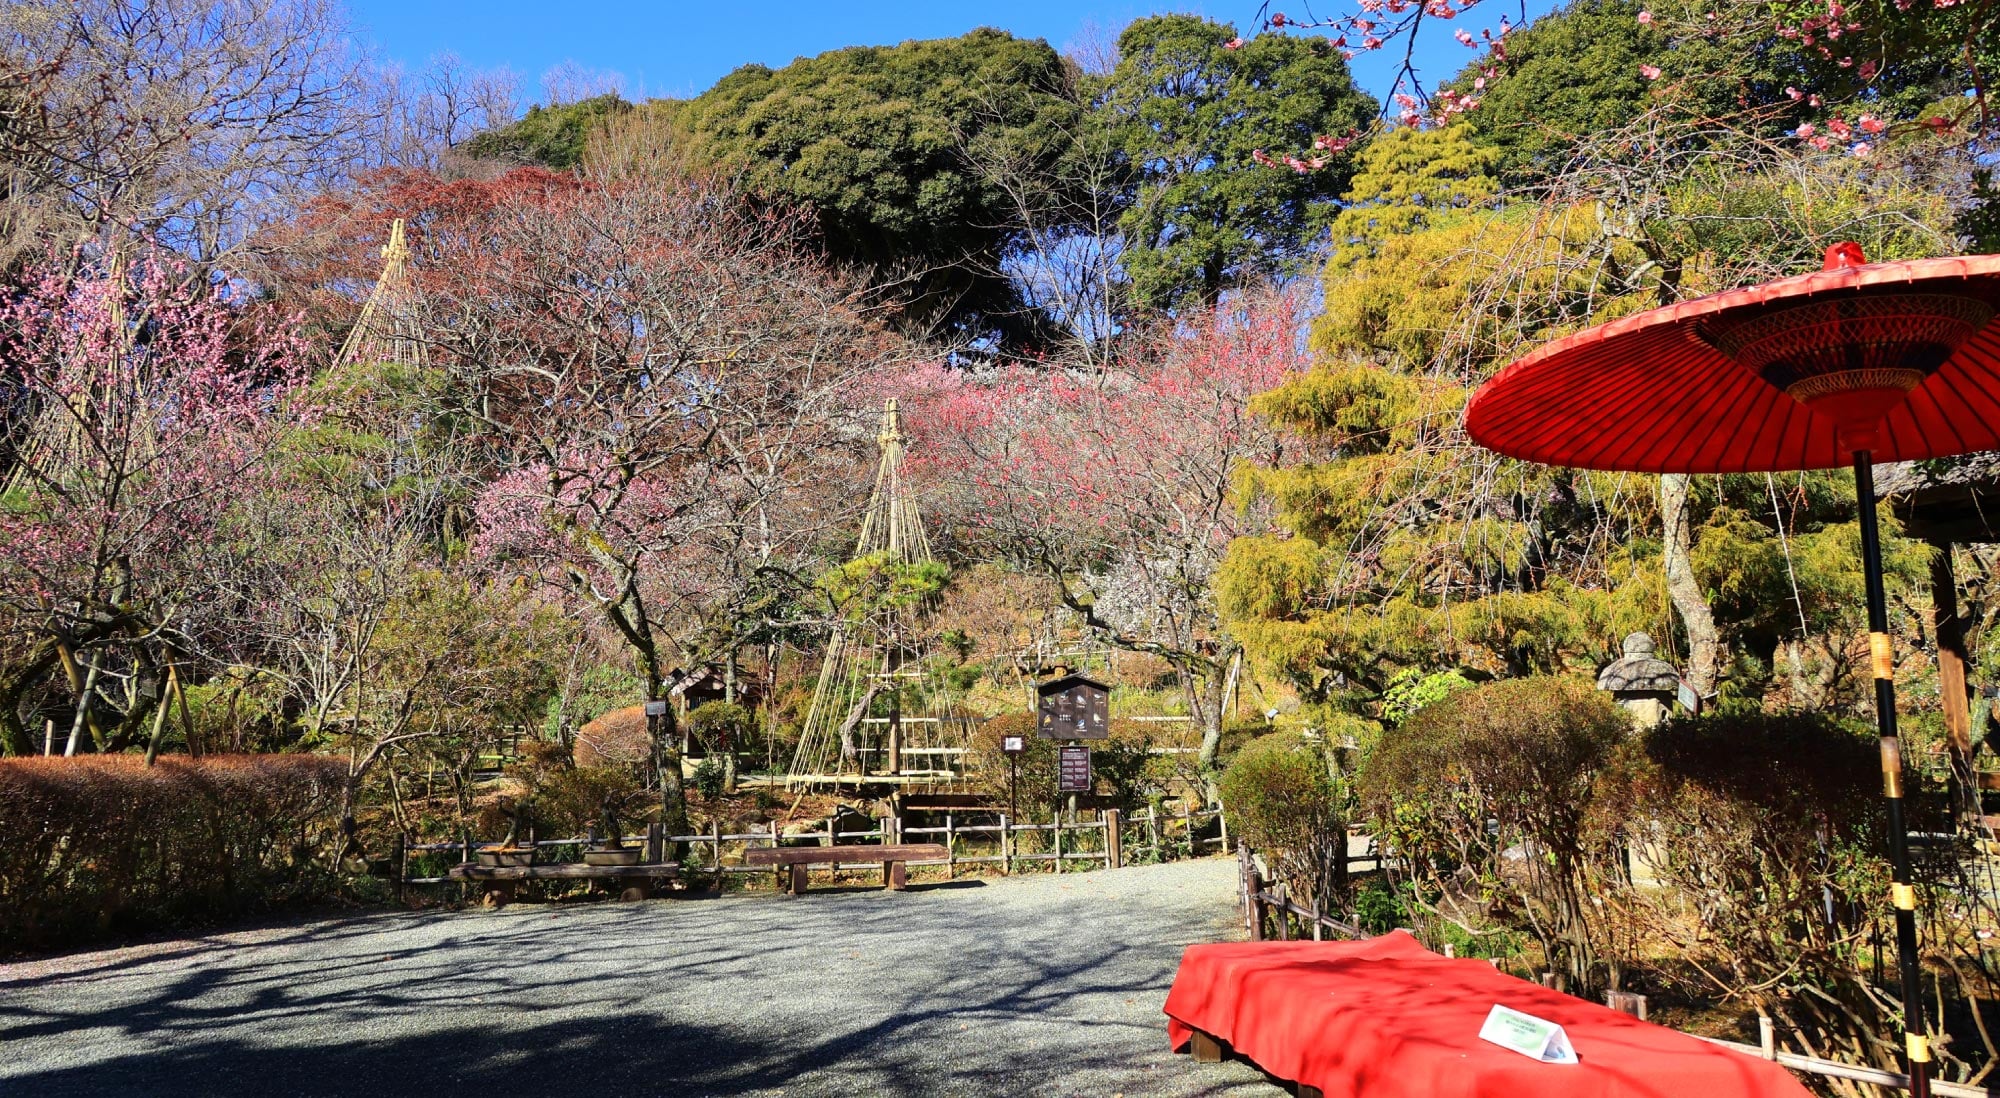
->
[0,754,346,954]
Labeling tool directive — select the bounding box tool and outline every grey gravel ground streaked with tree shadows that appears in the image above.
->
[0,860,1280,1098]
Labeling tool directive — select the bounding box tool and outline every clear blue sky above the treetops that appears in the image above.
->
[348,0,1554,102]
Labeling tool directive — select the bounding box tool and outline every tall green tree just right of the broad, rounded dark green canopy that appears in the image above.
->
[1098,16,1376,306]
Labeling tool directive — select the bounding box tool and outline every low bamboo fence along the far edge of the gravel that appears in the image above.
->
[390,800,1230,894]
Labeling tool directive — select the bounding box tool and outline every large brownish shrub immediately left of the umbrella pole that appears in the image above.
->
[1594,714,1888,1048]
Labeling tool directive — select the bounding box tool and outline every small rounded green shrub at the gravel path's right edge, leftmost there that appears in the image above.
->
[1222,732,1348,910]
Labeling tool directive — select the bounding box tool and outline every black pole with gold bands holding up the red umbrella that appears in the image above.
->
[1854,450,1930,1098]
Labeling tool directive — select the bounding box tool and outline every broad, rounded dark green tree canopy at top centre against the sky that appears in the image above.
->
[668,28,1084,346]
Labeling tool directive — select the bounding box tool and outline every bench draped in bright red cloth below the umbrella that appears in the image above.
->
[1166,930,1808,1098]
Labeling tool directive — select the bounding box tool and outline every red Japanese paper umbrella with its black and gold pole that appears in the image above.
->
[1466,244,2000,1098]
